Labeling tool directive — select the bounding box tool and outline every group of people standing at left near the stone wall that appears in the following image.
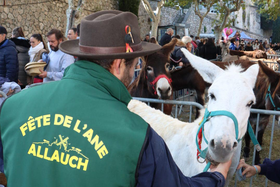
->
[0,26,78,88]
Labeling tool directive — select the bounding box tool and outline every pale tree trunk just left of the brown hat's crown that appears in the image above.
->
[65,0,83,37]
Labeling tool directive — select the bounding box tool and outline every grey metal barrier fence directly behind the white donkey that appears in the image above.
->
[133,97,280,187]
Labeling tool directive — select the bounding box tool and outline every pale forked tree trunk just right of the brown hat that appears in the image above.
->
[141,0,166,38]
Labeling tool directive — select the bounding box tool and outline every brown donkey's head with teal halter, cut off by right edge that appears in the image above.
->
[258,61,280,110]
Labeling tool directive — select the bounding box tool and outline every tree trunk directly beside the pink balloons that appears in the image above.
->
[214,0,243,41]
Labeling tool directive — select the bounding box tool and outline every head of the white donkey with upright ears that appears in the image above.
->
[182,49,259,162]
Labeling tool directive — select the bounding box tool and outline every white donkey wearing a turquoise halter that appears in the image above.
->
[128,49,259,186]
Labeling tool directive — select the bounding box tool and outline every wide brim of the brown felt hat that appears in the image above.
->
[59,39,161,59]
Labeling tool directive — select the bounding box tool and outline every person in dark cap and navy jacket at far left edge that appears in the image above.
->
[0,25,19,83]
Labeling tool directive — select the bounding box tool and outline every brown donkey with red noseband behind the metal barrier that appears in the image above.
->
[128,39,177,115]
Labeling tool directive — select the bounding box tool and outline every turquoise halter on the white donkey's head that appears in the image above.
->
[195,108,261,172]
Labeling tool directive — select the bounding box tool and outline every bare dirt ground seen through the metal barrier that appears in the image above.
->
[173,93,280,187]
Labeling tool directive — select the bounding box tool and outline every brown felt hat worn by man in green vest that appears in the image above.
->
[59,10,161,59]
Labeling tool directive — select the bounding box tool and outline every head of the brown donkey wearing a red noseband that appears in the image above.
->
[143,39,177,99]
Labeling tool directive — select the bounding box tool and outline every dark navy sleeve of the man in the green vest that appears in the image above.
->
[136,128,225,187]
